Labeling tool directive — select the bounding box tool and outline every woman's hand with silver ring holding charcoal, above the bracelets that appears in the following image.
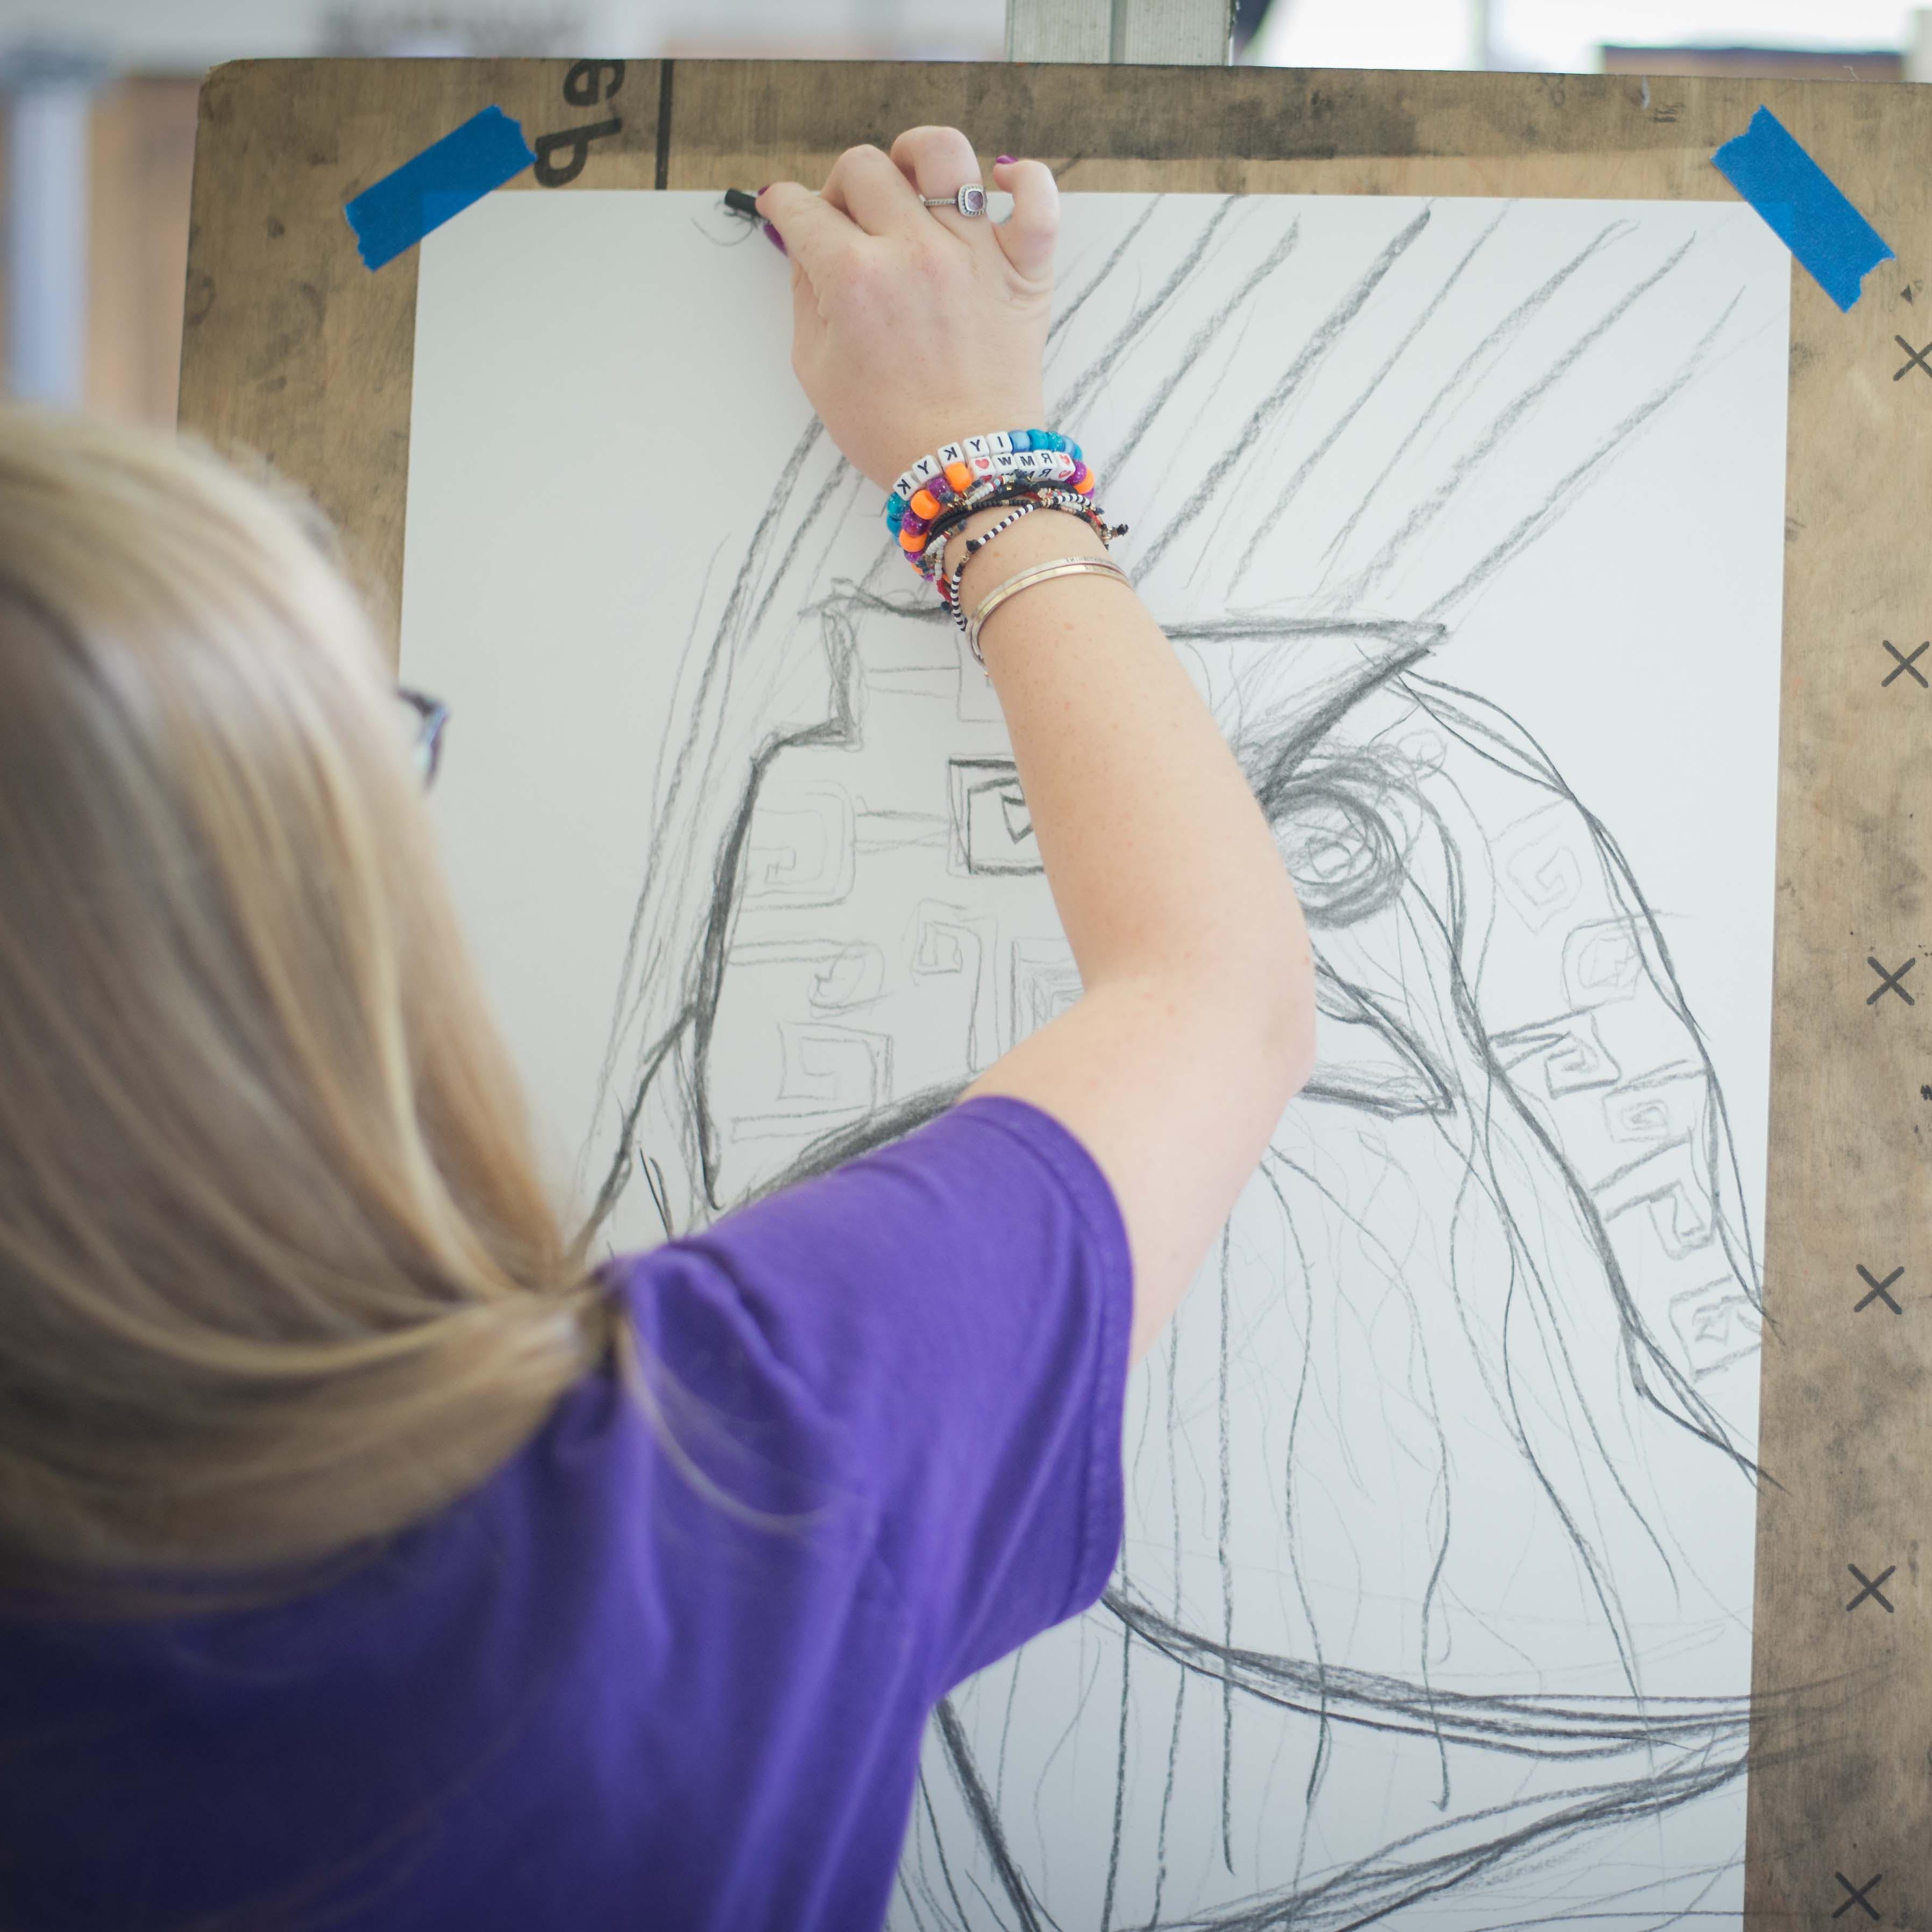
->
[757,127,1061,489]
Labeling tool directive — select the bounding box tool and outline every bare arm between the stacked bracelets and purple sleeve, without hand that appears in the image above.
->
[964,514,1314,1360]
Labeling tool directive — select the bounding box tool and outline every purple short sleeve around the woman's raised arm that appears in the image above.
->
[632,1097,1132,1696]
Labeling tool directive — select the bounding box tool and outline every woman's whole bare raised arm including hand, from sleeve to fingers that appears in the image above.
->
[759,127,1314,1358]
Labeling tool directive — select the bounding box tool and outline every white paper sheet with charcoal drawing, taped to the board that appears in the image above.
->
[404,195,1789,1932]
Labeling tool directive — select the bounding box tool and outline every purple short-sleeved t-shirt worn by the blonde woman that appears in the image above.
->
[0,1099,1132,1932]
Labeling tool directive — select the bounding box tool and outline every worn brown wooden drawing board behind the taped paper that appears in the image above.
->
[182,60,1932,1926]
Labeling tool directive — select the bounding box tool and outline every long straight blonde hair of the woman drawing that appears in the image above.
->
[0,414,613,1586]
